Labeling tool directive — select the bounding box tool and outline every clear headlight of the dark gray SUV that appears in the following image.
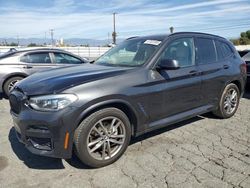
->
[29,94,78,111]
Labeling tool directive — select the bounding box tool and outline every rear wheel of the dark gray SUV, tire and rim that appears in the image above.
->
[213,83,240,119]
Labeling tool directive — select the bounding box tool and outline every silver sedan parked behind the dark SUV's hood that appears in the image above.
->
[0,48,87,96]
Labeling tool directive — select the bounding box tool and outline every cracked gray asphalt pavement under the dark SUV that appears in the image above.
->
[0,91,250,188]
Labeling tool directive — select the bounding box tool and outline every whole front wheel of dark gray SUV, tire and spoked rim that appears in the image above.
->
[74,108,131,168]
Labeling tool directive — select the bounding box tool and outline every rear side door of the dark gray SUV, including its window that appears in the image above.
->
[195,37,230,104]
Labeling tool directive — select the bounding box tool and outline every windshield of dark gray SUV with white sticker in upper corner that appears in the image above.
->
[95,38,161,67]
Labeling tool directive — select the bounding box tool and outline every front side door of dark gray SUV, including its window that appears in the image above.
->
[146,37,201,121]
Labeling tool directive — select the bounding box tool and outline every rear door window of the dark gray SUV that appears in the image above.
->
[195,38,216,64]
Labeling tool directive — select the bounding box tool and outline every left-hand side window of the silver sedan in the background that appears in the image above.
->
[20,53,51,64]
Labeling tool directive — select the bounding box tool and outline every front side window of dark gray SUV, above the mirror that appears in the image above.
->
[160,38,195,67]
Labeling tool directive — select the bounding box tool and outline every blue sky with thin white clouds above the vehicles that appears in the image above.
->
[0,0,250,39]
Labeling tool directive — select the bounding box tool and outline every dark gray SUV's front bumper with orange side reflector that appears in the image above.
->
[11,91,77,159]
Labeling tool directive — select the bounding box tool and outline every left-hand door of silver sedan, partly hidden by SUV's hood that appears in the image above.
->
[20,52,54,75]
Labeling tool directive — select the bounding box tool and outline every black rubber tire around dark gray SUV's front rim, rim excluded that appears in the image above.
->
[76,108,131,167]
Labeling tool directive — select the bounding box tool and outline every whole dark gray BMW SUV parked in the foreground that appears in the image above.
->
[9,32,246,167]
